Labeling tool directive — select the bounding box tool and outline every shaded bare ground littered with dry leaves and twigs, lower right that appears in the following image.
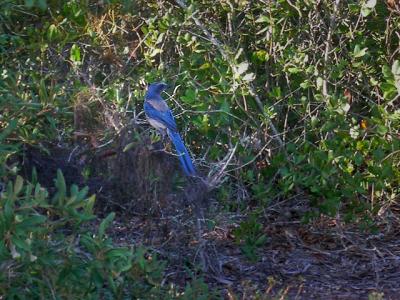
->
[102,210,400,299]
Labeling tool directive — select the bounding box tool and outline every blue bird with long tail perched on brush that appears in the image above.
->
[144,82,196,176]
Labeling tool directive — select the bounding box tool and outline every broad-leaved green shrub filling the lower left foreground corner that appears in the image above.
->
[0,172,168,299]
